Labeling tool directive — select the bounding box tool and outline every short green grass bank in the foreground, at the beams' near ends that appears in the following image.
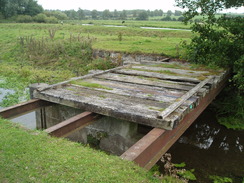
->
[0,119,164,183]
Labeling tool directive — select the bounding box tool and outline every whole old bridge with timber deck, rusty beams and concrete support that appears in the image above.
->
[0,59,228,169]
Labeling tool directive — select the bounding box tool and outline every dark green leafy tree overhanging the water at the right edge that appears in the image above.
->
[177,0,244,128]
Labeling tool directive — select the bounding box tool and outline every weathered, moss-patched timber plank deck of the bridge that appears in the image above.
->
[34,62,227,129]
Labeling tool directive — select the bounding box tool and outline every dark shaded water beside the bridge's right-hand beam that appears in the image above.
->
[169,108,244,183]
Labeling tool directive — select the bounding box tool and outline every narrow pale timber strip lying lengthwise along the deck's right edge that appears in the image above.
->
[158,76,214,119]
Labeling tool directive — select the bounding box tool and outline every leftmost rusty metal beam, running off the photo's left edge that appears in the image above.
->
[0,99,52,119]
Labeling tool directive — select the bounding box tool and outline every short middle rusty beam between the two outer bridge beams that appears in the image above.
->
[45,112,101,137]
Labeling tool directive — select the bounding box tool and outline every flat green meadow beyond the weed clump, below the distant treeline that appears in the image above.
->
[0,24,192,56]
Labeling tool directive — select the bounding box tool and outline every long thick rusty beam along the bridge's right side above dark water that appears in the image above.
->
[121,72,228,170]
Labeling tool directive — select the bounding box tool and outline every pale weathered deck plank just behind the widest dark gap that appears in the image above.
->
[113,69,201,83]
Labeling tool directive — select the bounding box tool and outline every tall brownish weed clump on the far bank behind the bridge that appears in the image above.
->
[19,29,116,76]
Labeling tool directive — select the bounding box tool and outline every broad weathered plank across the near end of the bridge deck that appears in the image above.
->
[34,88,177,129]
